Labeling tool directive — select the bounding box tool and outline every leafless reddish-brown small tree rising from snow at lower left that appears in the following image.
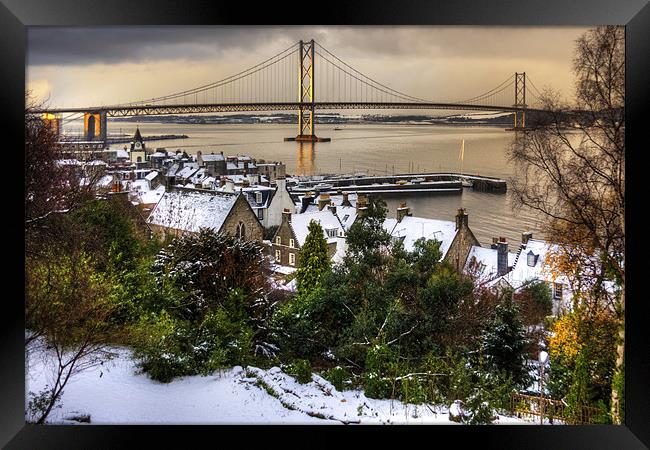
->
[25,251,121,423]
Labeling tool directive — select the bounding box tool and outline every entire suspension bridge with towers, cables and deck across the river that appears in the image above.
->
[36,39,542,142]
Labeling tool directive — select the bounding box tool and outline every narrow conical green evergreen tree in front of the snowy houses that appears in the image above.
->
[296,220,330,294]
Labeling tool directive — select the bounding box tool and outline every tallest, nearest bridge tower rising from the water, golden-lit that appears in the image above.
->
[285,39,330,142]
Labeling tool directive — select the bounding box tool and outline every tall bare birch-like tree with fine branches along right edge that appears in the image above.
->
[510,26,625,423]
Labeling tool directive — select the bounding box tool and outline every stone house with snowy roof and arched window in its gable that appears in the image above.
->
[147,188,264,241]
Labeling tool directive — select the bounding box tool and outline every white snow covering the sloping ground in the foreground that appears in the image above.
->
[26,349,526,425]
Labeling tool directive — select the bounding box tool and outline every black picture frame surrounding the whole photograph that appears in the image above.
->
[0,0,650,449]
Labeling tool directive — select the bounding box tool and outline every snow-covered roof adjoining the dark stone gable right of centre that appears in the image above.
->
[391,216,456,258]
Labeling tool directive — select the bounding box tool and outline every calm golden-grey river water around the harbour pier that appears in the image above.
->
[67,122,541,251]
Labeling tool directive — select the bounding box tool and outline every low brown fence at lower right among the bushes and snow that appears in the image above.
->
[510,392,602,425]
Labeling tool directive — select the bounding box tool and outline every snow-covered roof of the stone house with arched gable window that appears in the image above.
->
[147,189,238,232]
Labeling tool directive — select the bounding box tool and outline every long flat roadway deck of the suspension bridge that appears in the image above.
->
[35,102,543,117]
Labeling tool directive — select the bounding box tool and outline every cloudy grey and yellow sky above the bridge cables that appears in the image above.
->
[26,26,587,107]
